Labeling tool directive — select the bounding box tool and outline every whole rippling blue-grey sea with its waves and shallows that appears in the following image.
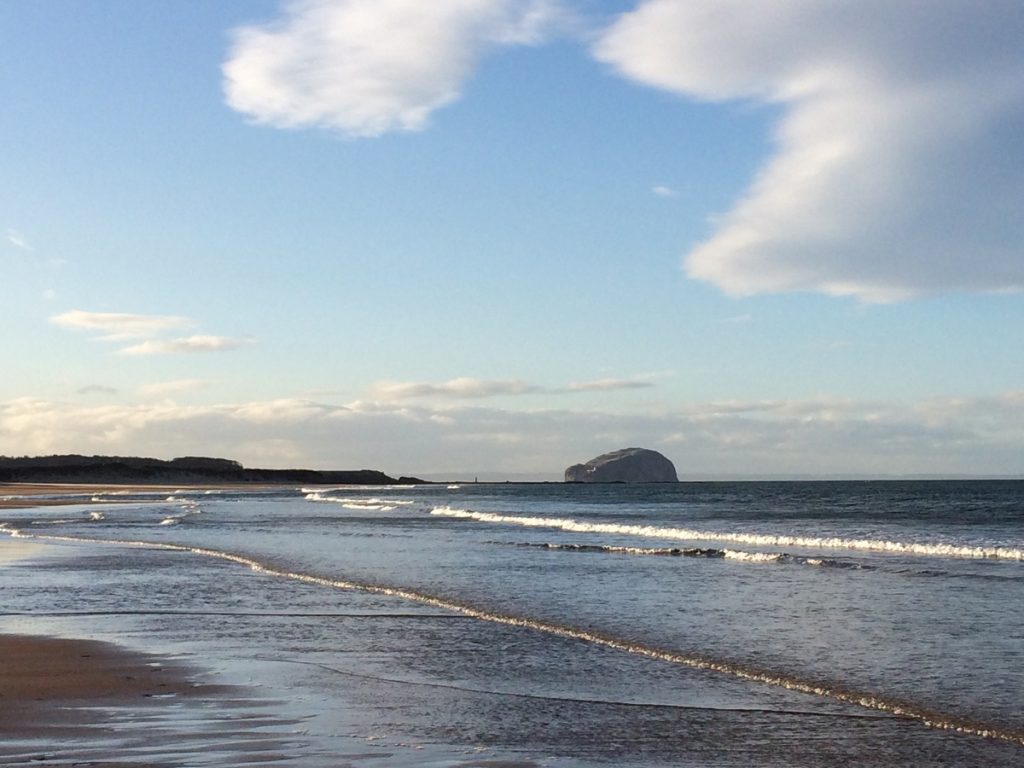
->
[0,481,1024,768]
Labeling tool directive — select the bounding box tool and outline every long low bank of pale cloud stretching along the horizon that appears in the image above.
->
[0,392,1024,478]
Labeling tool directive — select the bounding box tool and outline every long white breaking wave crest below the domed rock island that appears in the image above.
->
[430,507,1024,561]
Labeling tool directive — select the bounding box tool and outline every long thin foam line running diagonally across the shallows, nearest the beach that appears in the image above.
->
[0,523,1024,746]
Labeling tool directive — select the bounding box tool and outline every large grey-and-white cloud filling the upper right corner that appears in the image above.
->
[594,0,1024,301]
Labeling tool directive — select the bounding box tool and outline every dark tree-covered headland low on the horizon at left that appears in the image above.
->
[0,455,426,485]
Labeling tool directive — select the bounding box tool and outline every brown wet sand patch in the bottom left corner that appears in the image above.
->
[0,635,311,768]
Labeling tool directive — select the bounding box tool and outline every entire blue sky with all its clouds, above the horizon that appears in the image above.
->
[0,0,1024,479]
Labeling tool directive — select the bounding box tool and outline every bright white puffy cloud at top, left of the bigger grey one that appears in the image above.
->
[223,0,558,136]
